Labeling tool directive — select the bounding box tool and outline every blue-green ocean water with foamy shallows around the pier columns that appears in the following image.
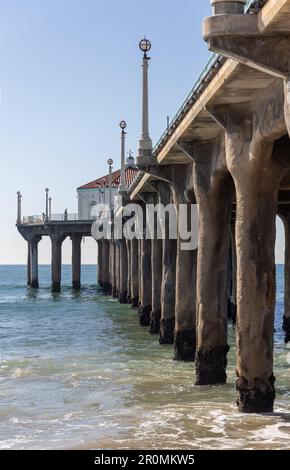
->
[0,266,290,449]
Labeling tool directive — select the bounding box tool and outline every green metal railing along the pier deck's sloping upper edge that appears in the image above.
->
[153,0,255,155]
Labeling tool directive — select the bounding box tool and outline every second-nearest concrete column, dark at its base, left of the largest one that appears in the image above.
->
[193,137,234,385]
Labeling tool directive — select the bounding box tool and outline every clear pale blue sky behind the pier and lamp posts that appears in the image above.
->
[0,0,283,264]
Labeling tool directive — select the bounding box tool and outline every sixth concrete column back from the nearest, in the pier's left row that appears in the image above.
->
[139,239,152,326]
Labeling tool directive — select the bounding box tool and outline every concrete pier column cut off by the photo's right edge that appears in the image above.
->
[278,205,290,344]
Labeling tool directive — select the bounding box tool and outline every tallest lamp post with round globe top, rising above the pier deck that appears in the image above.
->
[138,38,152,162]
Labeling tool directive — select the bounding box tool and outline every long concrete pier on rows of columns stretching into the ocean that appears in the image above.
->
[17,0,290,413]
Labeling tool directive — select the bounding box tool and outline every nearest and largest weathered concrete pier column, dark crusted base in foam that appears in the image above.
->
[236,174,277,412]
